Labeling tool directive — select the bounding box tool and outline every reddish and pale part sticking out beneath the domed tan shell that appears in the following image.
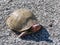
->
[18,24,42,37]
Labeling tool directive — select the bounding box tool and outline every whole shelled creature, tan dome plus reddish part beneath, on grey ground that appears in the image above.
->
[6,8,42,37]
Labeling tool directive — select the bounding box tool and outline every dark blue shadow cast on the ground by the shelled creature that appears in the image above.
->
[21,28,53,42]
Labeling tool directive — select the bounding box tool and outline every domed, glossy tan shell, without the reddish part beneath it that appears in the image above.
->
[6,9,37,32]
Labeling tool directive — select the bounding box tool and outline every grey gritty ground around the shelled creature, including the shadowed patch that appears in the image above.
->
[0,0,60,45]
